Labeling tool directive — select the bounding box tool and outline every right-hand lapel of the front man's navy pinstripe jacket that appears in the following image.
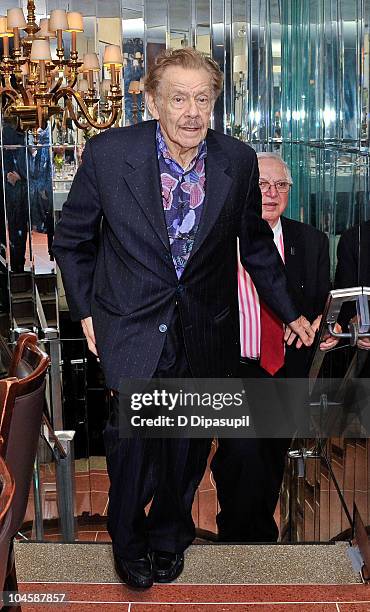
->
[184,130,232,266]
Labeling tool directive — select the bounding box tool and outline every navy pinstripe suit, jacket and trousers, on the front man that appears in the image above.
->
[53,121,299,558]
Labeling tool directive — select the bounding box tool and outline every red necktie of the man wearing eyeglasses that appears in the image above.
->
[260,301,284,376]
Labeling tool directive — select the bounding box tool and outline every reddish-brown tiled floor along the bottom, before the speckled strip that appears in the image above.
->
[19,583,370,612]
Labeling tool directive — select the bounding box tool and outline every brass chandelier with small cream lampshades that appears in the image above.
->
[0,0,123,136]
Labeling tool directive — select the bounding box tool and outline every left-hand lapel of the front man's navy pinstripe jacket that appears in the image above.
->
[124,121,170,250]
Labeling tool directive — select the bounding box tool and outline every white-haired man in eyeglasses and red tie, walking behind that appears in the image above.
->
[212,153,336,542]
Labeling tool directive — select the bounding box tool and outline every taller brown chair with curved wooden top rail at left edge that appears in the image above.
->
[0,333,50,612]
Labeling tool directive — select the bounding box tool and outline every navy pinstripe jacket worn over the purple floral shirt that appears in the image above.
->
[53,121,299,389]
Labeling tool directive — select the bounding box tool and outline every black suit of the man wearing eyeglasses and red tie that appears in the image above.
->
[211,217,330,542]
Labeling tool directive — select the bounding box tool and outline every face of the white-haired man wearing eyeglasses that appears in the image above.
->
[258,157,289,227]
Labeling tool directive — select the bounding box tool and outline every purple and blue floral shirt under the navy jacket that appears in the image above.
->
[157,124,207,278]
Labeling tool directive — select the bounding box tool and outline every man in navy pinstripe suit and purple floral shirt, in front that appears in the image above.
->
[54,49,314,587]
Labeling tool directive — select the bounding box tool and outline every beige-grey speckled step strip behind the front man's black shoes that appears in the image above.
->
[15,541,360,584]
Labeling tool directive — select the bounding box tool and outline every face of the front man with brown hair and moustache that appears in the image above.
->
[147,66,214,157]
